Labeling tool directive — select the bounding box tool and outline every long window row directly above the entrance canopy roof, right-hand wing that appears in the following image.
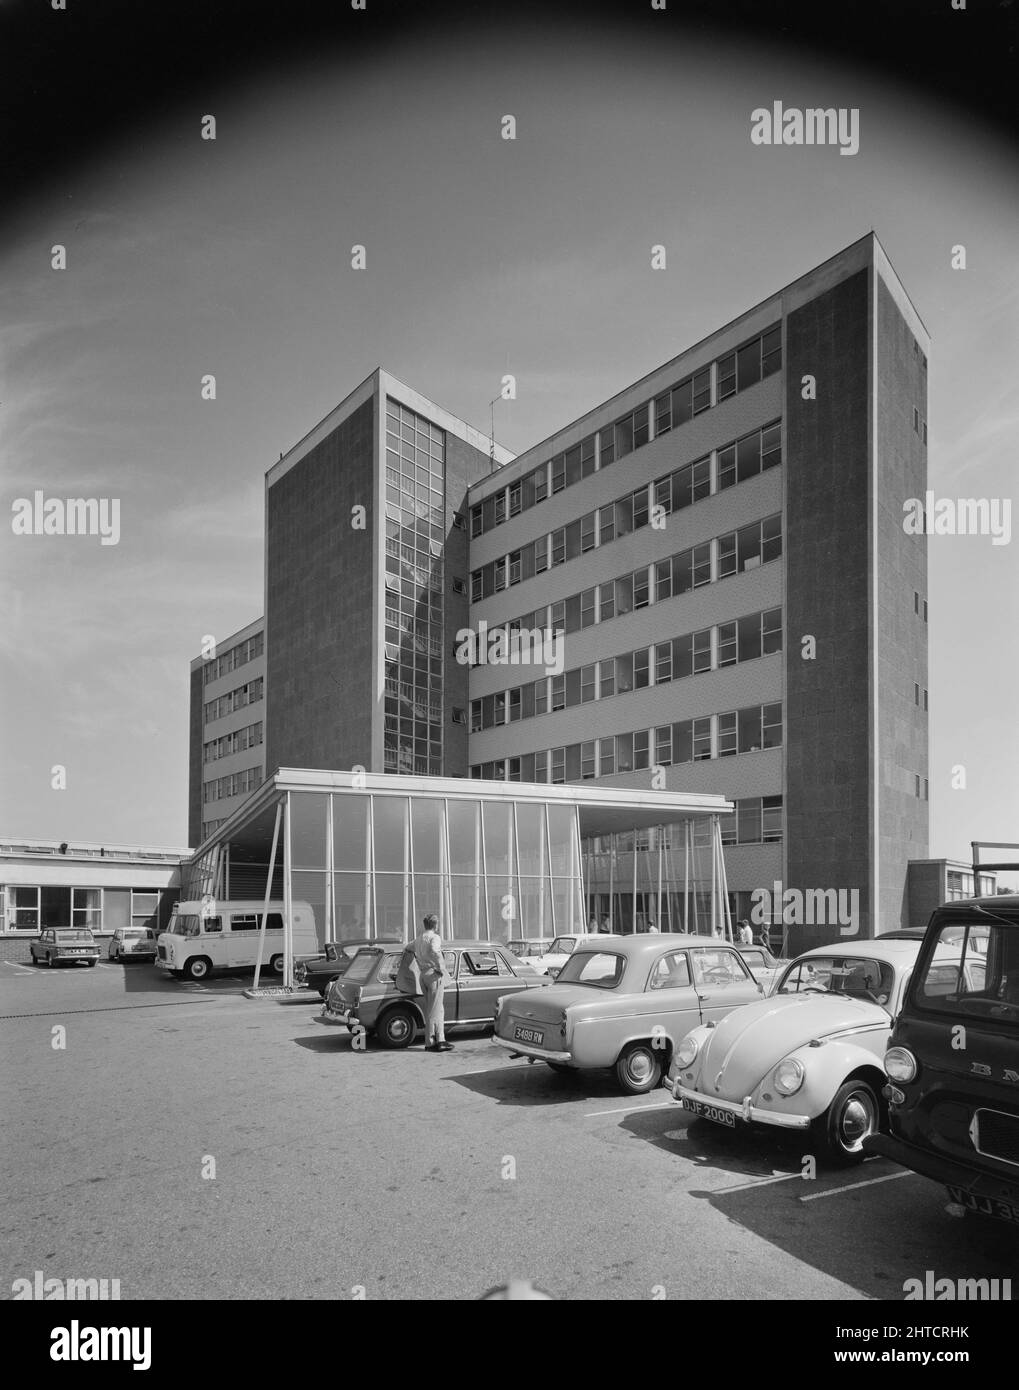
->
[471,701,783,783]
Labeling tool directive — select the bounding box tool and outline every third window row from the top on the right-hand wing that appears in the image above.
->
[464,512,781,655]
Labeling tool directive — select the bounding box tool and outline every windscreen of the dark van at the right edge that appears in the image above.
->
[911,922,1019,1026]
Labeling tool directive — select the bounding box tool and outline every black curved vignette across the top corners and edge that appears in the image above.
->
[0,0,1019,218]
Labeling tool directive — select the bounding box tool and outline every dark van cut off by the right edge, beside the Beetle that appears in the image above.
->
[863,894,1019,1225]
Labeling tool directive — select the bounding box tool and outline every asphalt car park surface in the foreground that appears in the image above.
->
[0,951,1015,1300]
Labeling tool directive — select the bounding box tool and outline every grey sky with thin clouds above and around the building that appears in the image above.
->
[0,10,1019,878]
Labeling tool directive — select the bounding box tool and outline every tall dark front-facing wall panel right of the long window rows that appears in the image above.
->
[785,270,873,951]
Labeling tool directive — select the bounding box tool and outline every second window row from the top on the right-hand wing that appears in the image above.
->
[471,421,781,602]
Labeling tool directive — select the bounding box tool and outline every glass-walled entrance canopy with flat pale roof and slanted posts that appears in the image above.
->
[182,769,733,970]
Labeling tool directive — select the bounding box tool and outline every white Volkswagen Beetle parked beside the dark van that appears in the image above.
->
[670,938,939,1163]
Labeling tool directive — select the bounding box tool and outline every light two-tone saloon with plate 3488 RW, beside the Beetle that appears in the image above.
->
[492,933,763,1095]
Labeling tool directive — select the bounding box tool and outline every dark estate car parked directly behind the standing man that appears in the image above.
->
[317,941,548,1048]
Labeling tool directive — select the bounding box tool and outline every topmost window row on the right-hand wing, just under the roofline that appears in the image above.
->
[470,324,781,537]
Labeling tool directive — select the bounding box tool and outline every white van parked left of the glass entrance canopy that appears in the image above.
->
[156,898,323,980]
